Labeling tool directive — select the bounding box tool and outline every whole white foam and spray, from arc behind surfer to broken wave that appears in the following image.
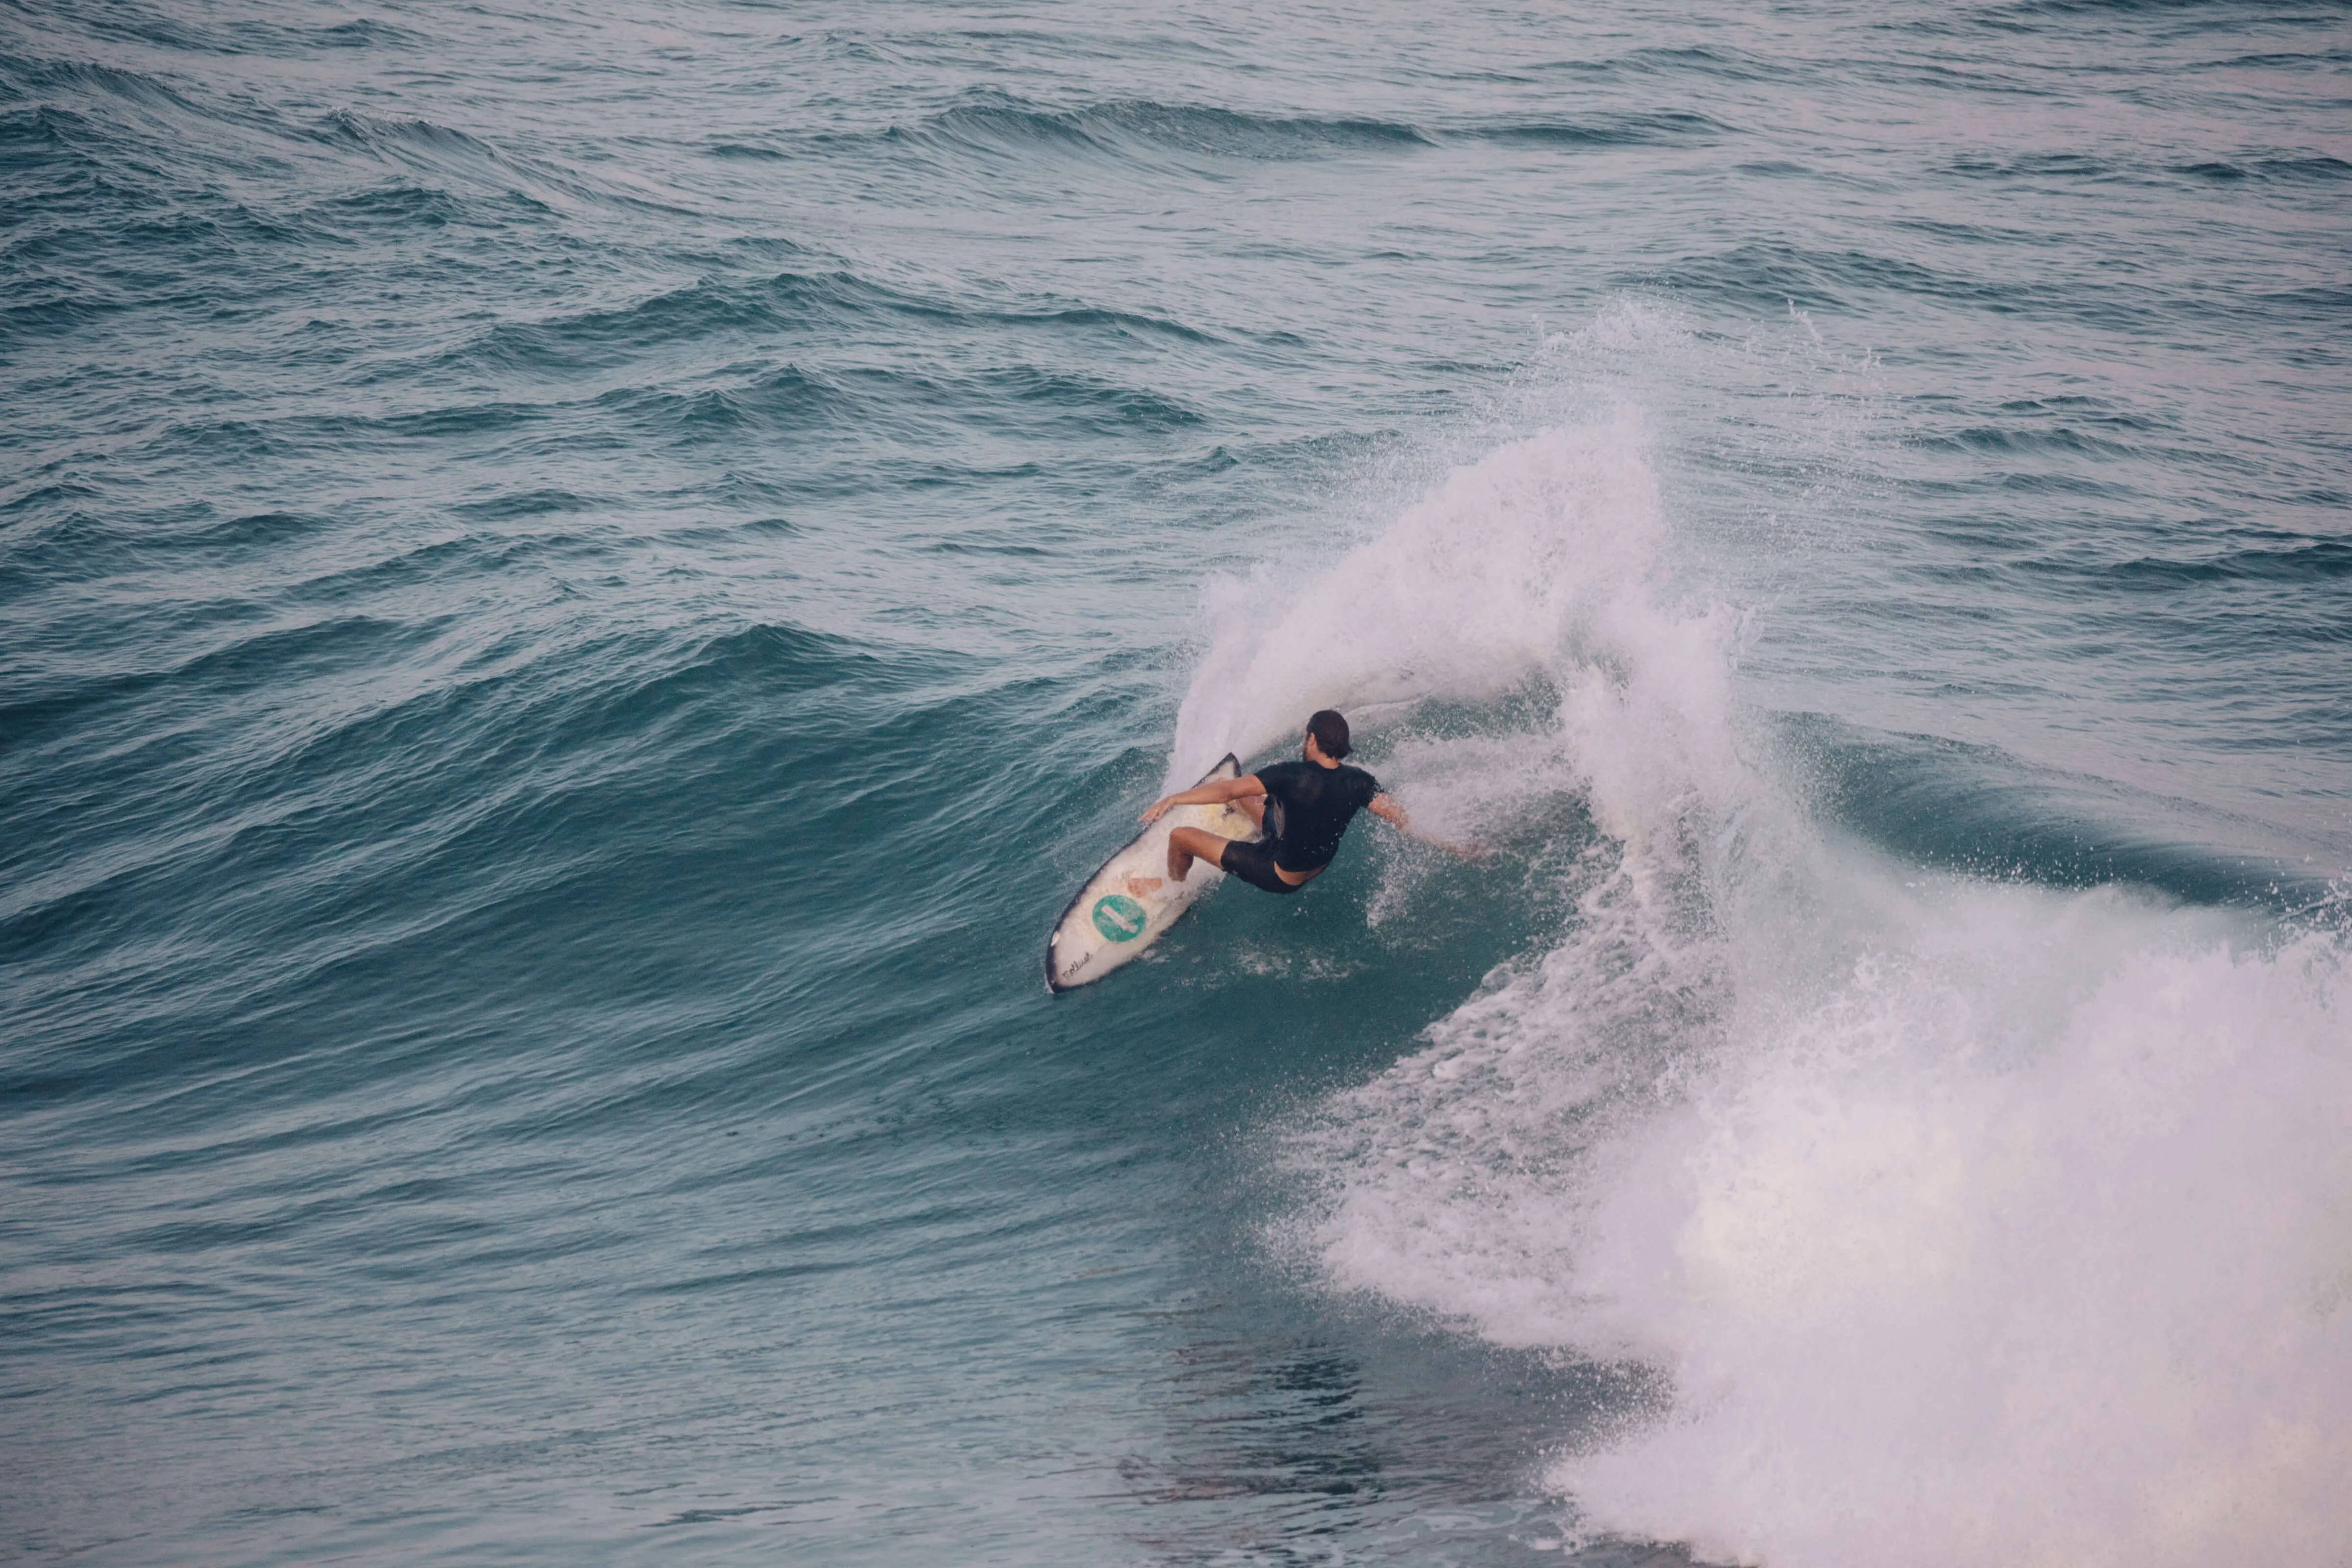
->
[1195,394,2352,1568]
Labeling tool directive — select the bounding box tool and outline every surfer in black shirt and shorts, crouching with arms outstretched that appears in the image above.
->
[1127,708,1479,898]
